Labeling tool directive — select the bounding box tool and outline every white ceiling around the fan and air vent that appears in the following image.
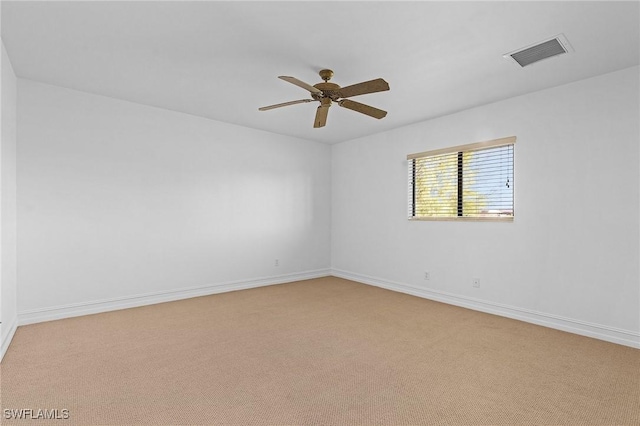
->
[2,1,640,143]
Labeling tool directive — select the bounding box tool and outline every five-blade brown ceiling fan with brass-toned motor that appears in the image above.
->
[258,70,389,128]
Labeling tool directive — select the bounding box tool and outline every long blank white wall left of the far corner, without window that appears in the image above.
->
[18,79,331,323]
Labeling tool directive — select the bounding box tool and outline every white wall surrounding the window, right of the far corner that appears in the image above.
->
[332,67,640,347]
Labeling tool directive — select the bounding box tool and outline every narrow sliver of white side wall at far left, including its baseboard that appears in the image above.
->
[0,40,18,360]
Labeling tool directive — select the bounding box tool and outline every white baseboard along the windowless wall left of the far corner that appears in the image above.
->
[18,269,331,326]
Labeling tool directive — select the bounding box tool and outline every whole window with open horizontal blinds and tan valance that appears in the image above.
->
[407,136,516,221]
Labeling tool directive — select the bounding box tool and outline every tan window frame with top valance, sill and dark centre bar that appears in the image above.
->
[407,136,516,222]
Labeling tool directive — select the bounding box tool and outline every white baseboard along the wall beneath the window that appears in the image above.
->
[331,269,640,349]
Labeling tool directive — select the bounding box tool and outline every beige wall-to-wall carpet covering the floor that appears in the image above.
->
[1,278,640,425]
